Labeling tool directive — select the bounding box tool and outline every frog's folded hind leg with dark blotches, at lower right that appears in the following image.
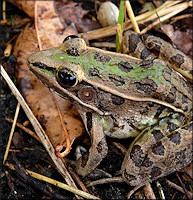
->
[122,122,192,186]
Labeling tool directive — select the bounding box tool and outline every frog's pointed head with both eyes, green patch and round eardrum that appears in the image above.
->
[28,36,107,114]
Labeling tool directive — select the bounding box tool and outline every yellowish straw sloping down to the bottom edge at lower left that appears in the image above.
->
[6,163,100,199]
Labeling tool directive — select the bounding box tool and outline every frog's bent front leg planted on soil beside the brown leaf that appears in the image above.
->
[75,112,108,176]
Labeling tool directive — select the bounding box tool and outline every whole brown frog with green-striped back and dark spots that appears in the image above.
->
[28,31,192,188]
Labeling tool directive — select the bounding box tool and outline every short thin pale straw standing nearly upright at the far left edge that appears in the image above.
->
[3,102,20,164]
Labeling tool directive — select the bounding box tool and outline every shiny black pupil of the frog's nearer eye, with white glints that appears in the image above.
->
[58,72,76,87]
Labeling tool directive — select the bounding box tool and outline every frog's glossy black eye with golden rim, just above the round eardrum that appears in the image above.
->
[56,69,78,87]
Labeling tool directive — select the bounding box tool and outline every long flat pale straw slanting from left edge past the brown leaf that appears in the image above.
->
[0,65,81,197]
